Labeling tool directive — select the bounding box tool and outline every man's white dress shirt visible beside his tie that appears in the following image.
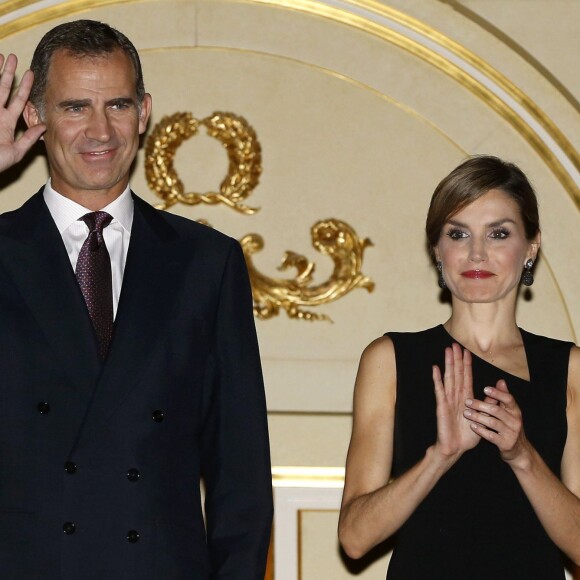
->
[44,179,133,316]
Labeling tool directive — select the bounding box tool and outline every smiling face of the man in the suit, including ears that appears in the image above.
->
[25,50,151,207]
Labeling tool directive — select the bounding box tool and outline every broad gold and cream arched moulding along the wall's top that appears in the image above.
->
[0,0,580,210]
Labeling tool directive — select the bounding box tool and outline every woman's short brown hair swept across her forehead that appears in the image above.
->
[425,155,540,251]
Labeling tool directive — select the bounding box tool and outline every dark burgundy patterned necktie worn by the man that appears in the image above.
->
[76,211,113,359]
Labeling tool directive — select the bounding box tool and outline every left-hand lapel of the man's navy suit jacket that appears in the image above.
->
[0,189,101,399]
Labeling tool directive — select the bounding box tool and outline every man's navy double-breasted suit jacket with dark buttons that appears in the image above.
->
[0,191,272,580]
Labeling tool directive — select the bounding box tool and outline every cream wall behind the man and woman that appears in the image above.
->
[0,0,580,580]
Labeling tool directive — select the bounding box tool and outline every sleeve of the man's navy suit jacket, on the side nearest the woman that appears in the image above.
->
[202,240,273,580]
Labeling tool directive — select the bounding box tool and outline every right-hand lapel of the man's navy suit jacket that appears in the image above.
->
[78,196,191,435]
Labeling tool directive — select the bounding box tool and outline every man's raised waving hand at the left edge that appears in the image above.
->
[0,54,46,171]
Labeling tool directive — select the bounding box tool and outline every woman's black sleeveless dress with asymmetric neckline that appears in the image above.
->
[387,325,572,580]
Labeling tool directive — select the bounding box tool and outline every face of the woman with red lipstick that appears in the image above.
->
[434,189,540,303]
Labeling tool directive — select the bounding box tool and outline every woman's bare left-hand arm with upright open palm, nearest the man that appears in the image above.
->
[338,337,480,558]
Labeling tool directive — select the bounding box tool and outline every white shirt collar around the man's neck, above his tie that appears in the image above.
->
[43,178,133,234]
